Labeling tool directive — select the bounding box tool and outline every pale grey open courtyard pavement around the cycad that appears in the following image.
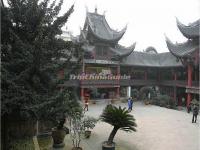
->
[65,102,200,150]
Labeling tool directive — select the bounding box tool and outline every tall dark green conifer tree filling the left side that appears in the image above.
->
[1,0,82,142]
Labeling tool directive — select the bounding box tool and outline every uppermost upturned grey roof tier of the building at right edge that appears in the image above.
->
[176,18,200,39]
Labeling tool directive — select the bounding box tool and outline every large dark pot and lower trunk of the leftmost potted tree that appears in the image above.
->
[52,119,69,148]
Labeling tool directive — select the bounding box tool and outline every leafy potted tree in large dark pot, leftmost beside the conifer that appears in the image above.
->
[49,89,82,148]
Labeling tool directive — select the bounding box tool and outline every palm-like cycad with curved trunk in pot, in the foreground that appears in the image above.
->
[100,105,137,150]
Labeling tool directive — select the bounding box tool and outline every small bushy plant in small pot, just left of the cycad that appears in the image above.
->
[83,116,98,138]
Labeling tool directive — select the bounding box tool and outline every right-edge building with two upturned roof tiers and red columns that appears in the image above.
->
[166,20,200,106]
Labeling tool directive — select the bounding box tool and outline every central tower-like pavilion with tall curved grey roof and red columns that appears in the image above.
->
[79,9,135,101]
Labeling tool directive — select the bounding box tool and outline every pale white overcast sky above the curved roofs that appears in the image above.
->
[62,0,200,53]
